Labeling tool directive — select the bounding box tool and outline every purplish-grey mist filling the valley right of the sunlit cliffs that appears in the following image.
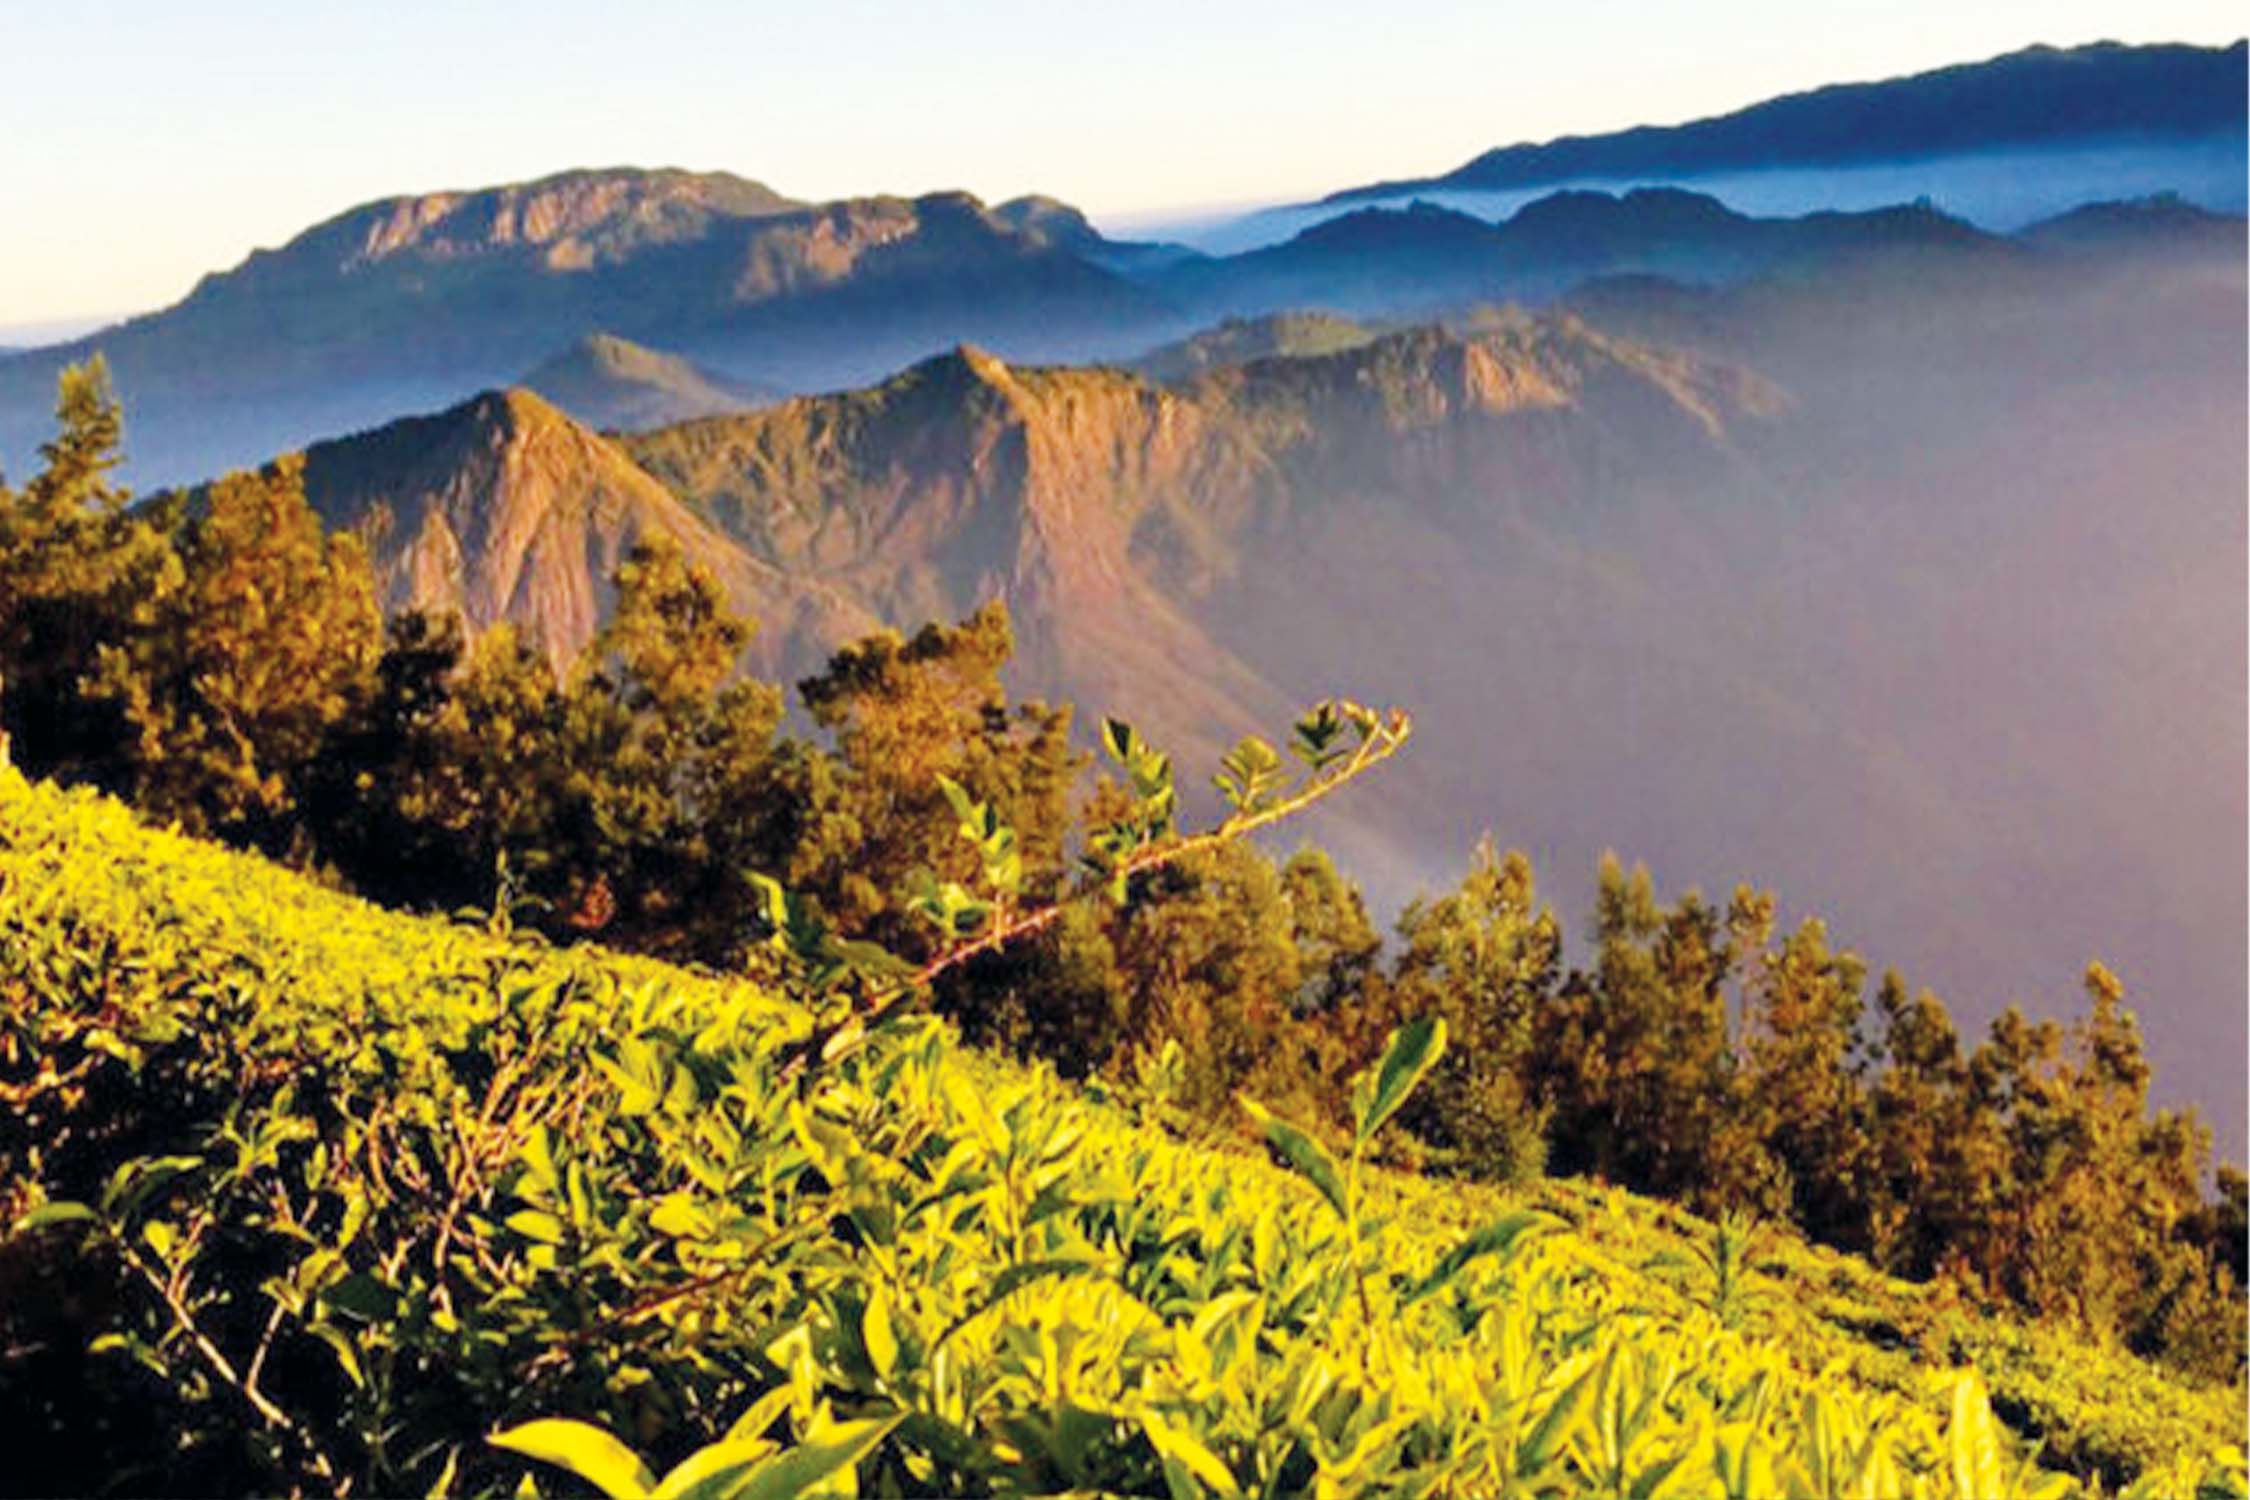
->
[1269,256,2250,1158]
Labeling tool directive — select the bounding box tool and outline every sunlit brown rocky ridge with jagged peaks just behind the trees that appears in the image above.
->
[306,322,1780,787]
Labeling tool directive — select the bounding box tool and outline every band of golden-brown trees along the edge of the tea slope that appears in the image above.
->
[0,364,2246,1421]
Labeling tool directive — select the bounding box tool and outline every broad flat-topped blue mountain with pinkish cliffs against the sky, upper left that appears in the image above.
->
[0,169,1179,481]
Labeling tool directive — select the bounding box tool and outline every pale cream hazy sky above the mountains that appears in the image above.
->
[0,0,2243,328]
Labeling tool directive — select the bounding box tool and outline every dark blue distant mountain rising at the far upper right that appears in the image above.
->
[1323,43,2246,205]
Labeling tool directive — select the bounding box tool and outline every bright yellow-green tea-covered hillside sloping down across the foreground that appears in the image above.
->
[0,769,2246,1500]
